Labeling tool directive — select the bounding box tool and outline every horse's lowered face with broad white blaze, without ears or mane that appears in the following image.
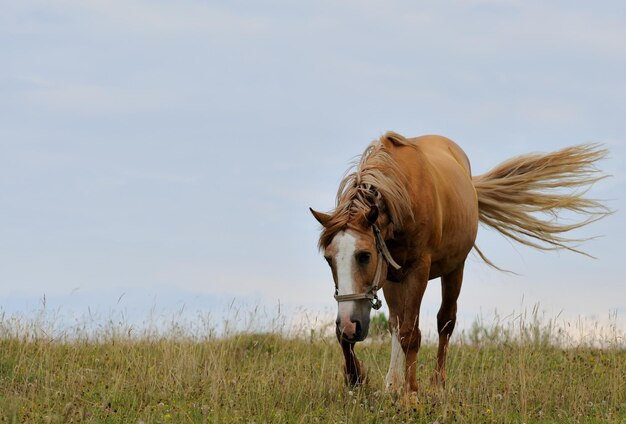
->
[324,229,379,342]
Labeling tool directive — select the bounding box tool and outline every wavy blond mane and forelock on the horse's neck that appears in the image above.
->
[319,131,413,249]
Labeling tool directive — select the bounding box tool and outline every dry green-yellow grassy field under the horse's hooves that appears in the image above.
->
[0,319,626,423]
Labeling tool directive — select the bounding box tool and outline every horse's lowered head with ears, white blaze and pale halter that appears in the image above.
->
[311,206,386,342]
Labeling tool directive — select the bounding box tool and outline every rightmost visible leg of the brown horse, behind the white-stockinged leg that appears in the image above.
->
[433,264,464,387]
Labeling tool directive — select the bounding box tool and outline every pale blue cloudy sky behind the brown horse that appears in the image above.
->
[0,0,626,338]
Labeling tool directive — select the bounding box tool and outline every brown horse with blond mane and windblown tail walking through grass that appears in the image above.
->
[311,132,610,393]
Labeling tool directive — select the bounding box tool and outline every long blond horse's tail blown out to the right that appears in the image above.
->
[473,144,611,268]
